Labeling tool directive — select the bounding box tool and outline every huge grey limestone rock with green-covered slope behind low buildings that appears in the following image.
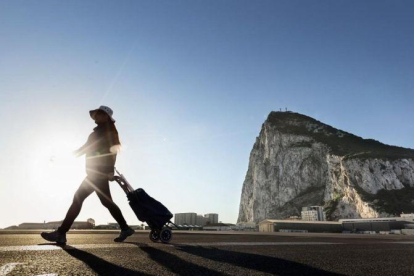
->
[238,112,414,223]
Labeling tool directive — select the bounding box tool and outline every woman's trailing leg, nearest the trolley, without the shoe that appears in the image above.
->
[95,179,129,230]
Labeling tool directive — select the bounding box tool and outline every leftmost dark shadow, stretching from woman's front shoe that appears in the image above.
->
[38,243,149,275]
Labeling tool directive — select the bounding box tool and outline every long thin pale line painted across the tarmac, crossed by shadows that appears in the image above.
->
[0,242,342,252]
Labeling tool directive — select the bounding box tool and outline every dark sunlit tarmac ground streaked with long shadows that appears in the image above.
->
[0,231,414,276]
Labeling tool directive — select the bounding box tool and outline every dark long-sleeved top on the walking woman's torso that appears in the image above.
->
[76,122,121,178]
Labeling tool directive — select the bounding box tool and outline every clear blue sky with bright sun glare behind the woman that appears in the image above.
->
[0,0,414,228]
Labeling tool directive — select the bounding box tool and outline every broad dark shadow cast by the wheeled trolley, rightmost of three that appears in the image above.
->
[176,246,343,276]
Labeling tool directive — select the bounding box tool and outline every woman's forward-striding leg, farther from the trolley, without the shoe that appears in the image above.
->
[58,178,95,234]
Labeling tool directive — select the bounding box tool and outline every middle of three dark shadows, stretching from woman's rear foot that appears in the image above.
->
[125,242,224,276]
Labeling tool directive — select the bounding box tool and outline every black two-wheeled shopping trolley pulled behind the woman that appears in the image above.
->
[114,169,178,243]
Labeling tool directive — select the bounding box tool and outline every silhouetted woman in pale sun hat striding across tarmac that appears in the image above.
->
[41,106,135,243]
